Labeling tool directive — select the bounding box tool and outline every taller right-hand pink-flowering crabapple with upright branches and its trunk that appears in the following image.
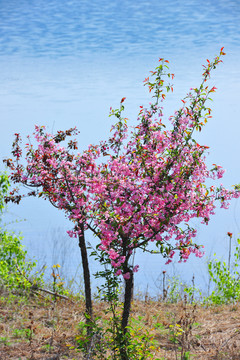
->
[88,49,239,334]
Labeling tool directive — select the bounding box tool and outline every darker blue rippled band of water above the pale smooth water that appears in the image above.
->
[0,0,240,58]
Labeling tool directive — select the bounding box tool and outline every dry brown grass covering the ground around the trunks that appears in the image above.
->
[0,297,240,360]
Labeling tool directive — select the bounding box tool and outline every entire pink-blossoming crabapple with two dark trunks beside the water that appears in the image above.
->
[5,49,239,344]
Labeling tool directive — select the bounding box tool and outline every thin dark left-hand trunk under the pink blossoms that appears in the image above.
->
[78,229,92,320]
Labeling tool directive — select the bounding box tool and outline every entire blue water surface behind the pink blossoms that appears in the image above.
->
[0,0,240,293]
